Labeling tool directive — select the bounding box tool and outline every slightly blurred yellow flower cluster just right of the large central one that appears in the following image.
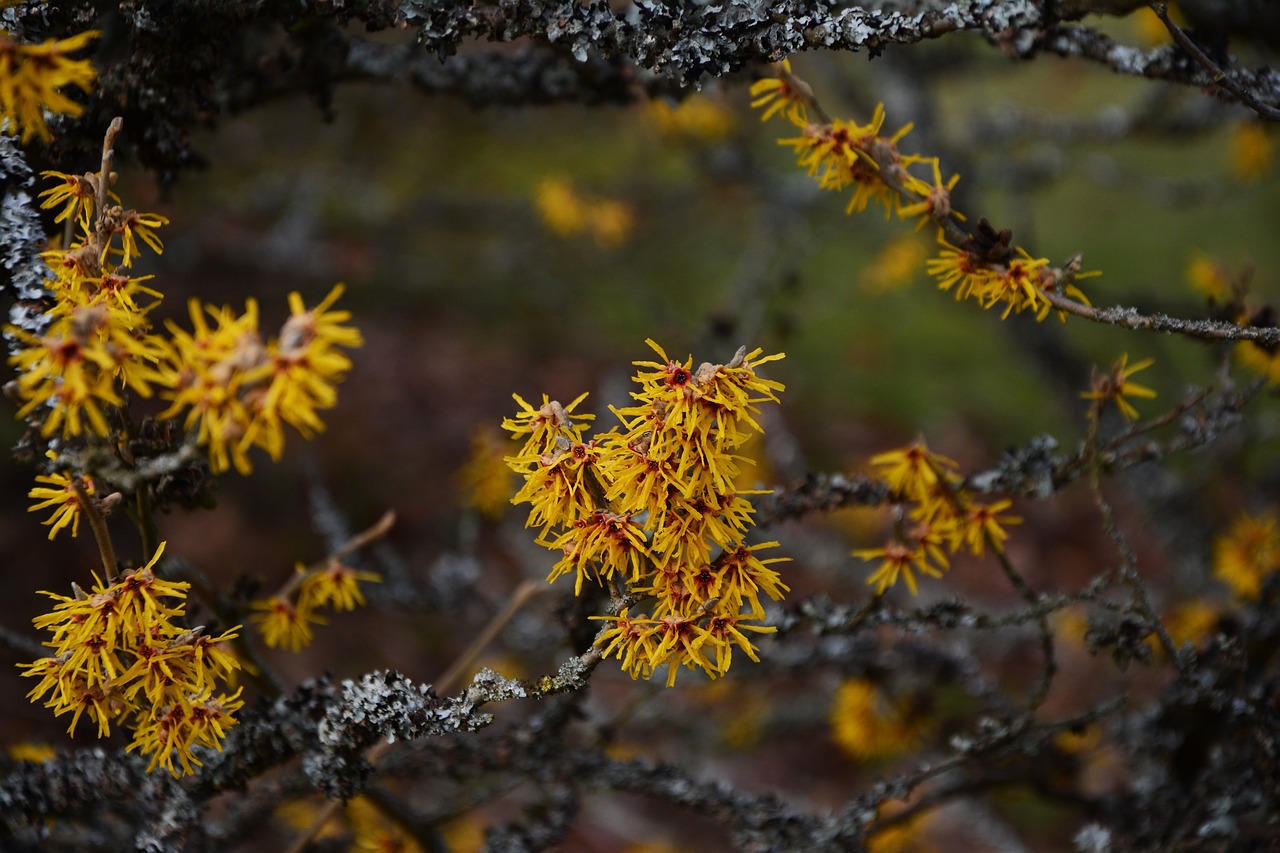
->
[854,439,1021,596]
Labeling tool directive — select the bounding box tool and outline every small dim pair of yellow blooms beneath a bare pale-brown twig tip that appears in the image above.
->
[250,558,381,652]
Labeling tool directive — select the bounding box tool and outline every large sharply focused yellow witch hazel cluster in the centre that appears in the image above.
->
[503,341,787,685]
